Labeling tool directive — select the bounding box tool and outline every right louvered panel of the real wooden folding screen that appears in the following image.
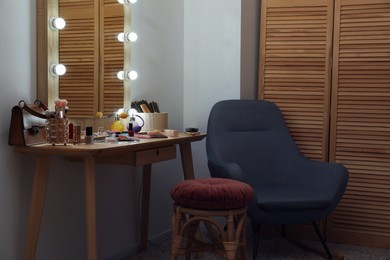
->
[328,0,390,248]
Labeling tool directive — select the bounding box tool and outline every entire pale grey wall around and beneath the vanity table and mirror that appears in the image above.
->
[0,0,256,260]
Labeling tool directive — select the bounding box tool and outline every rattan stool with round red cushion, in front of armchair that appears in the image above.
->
[171,178,253,260]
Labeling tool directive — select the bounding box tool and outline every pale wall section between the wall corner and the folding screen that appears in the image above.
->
[183,0,241,177]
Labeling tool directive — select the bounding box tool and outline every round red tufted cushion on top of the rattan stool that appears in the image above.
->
[171,178,253,210]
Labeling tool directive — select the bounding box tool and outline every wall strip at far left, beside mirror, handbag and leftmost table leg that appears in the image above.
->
[0,0,36,259]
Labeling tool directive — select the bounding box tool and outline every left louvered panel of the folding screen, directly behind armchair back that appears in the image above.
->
[259,0,333,160]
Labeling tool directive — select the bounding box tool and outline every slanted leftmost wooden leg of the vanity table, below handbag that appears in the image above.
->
[24,156,51,260]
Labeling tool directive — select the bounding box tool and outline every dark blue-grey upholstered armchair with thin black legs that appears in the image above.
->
[206,100,348,259]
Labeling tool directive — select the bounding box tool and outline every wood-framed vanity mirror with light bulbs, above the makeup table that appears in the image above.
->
[37,0,133,118]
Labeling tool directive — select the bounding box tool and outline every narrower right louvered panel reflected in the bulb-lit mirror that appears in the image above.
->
[100,0,124,114]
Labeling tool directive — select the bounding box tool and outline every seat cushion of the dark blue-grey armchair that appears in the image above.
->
[255,184,331,210]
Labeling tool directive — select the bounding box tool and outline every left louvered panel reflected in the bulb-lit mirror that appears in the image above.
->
[59,0,99,117]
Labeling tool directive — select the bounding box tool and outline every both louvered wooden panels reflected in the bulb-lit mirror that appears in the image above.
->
[59,0,124,118]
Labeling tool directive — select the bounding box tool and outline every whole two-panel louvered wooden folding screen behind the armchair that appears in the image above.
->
[259,0,390,248]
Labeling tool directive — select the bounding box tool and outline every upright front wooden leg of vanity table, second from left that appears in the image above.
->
[84,157,97,260]
